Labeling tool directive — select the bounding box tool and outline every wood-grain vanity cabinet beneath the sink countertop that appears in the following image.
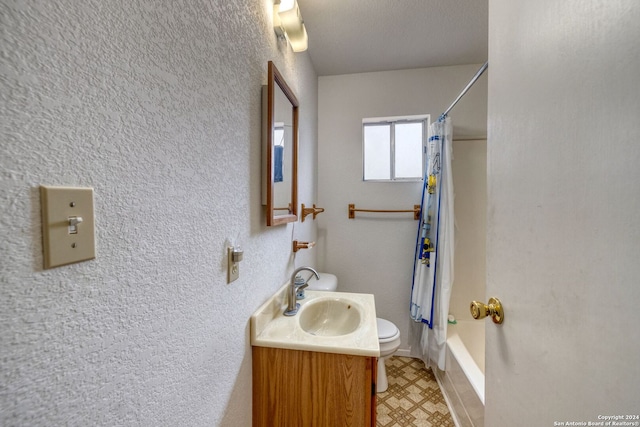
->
[252,346,377,427]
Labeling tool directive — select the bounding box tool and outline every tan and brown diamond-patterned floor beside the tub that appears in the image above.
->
[376,356,454,427]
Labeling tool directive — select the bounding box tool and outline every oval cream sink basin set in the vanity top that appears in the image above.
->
[298,298,362,337]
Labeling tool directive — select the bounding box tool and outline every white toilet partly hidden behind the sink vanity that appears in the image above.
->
[307,273,400,393]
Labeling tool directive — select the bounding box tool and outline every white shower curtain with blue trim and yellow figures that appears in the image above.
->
[410,116,455,370]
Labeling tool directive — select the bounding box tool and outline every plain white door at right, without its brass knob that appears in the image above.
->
[484,0,640,427]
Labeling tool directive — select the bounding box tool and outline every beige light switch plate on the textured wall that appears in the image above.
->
[40,185,96,268]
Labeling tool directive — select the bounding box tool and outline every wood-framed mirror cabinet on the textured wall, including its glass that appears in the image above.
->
[262,61,299,226]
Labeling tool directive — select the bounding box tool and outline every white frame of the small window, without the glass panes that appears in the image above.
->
[362,114,431,182]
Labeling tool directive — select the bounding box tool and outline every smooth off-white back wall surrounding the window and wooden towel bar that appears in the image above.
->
[318,64,487,349]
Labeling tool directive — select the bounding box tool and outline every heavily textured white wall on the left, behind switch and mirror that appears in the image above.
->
[0,0,317,426]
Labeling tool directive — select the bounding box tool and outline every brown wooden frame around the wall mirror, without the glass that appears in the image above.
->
[262,61,299,226]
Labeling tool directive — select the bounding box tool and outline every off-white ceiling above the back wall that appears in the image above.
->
[298,0,488,76]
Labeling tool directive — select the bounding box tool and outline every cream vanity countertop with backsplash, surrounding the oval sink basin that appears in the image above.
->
[251,284,380,357]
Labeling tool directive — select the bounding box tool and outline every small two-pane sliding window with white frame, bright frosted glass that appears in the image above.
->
[362,115,429,181]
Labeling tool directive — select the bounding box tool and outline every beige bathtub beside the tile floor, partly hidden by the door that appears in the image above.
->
[436,320,485,427]
